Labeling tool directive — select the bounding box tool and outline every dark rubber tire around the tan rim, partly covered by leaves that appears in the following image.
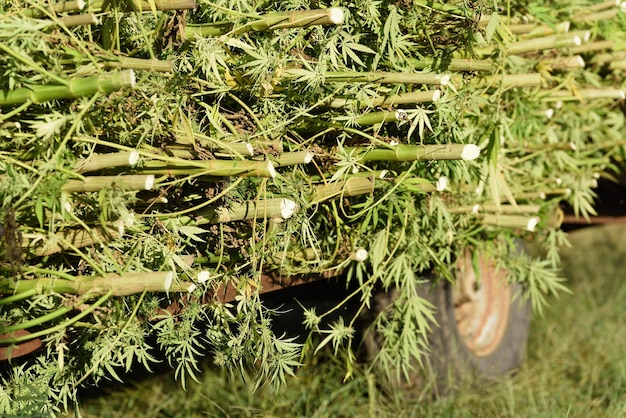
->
[363,280,531,398]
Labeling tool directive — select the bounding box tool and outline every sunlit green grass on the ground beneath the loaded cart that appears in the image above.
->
[70,225,626,417]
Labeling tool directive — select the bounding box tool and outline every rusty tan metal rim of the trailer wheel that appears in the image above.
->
[452,253,511,357]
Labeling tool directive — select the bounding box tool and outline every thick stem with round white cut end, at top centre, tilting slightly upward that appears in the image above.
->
[185,7,344,39]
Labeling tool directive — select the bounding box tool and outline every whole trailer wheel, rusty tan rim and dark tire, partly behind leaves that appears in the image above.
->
[366,250,531,397]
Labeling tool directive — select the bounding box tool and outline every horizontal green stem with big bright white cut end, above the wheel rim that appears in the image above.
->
[345,144,480,162]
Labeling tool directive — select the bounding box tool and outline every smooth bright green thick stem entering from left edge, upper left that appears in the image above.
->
[0,70,135,106]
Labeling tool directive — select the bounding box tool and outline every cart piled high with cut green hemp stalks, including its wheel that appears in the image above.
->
[0,0,626,415]
